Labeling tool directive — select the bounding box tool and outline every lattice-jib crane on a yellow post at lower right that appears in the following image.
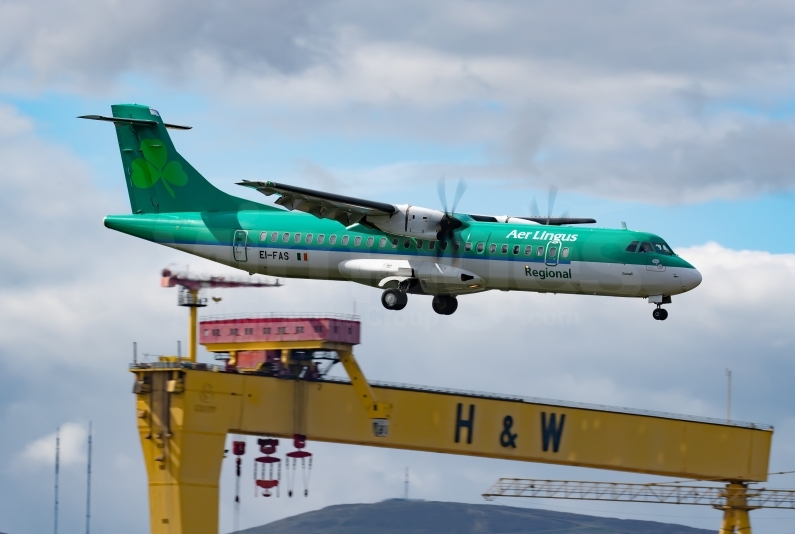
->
[483,478,795,534]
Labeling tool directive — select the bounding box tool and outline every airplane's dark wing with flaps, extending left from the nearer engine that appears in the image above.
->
[237,180,398,226]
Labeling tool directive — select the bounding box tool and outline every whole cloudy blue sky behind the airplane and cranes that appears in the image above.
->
[0,0,795,534]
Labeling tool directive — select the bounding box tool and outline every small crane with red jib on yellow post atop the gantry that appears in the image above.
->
[160,269,282,362]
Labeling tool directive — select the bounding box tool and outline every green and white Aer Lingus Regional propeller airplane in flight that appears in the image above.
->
[79,104,702,320]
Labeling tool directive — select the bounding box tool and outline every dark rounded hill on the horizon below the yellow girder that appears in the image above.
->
[240,499,717,534]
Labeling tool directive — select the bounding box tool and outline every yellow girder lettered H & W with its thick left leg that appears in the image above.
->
[133,368,772,534]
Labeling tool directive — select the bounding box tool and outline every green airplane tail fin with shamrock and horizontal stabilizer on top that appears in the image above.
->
[82,104,272,213]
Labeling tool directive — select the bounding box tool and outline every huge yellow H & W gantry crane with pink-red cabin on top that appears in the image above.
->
[130,280,773,534]
